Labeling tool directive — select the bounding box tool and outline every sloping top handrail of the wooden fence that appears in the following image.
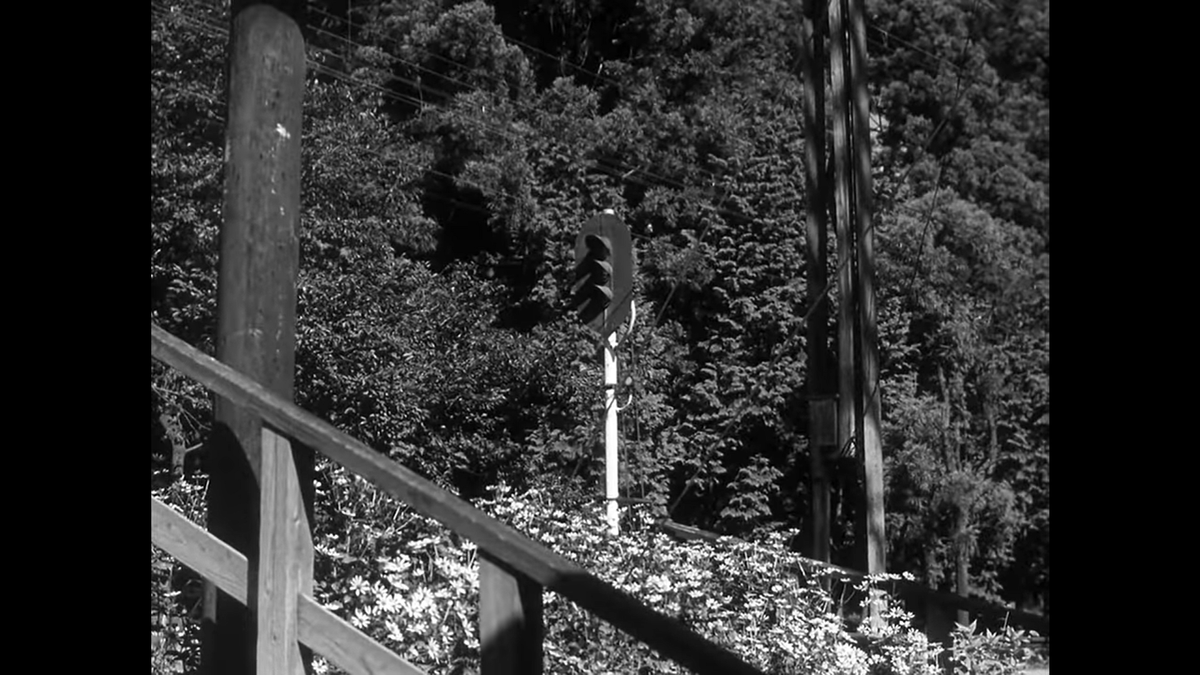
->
[150,322,761,675]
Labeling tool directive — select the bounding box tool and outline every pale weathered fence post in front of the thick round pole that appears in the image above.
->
[253,429,312,675]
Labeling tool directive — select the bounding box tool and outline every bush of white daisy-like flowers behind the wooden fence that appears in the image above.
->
[152,466,1041,675]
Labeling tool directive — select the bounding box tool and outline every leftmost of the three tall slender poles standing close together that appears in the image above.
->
[800,0,838,562]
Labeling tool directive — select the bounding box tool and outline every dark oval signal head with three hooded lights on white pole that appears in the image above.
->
[571,211,634,338]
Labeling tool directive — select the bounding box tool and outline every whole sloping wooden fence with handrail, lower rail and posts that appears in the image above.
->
[150,323,761,675]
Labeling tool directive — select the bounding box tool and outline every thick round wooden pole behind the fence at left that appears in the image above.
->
[200,1,313,675]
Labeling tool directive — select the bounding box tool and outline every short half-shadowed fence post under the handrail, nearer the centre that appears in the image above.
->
[479,552,542,675]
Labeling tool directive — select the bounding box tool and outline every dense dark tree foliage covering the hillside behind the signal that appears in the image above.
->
[151,0,1050,607]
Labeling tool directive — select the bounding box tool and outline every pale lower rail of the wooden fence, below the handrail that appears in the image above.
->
[150,487,427,675]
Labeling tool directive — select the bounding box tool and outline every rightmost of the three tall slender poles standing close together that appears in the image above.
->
[849,0,887,574]
